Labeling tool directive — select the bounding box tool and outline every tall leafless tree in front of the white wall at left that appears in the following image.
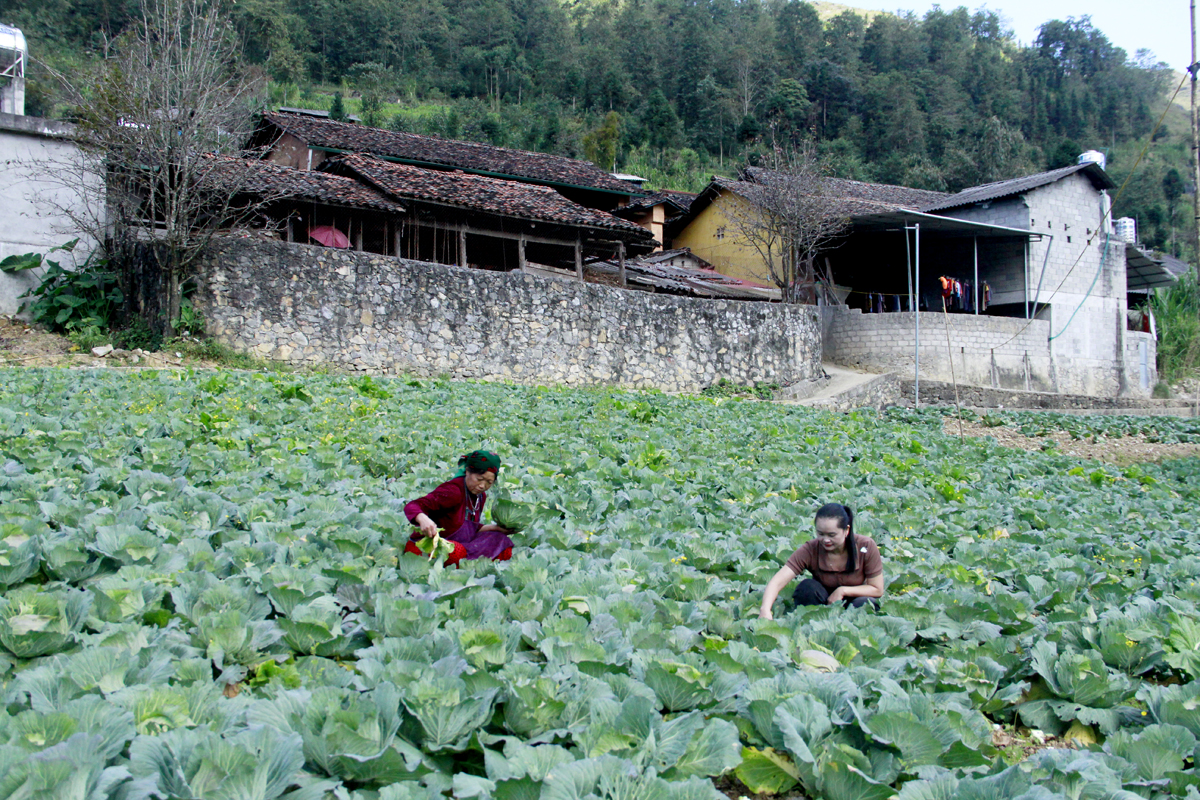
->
[42,0,268,329]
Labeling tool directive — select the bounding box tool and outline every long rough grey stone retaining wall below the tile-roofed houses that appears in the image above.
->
[198,239,821,391]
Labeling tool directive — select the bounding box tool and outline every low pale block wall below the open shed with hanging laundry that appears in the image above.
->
[822,306,1055,391]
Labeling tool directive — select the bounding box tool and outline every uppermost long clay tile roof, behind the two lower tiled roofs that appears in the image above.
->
[263,112,641,194]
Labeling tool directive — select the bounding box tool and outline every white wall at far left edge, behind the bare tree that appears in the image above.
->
[0,114,100,314]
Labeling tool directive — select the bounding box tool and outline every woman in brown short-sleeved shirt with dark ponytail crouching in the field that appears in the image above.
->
[758,503,883,619]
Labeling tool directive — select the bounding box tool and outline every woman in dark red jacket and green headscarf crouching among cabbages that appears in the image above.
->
[404,450,512,566]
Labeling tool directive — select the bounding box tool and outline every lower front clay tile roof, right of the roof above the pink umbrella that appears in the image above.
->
[322,154,652,240]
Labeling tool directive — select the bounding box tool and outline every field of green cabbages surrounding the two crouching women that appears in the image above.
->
[0,369,1200,800]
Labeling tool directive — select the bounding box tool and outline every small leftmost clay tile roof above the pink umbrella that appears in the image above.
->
[214,158,404,213]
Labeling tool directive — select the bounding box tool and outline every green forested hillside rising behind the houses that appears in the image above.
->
[7,0,1190,260]
